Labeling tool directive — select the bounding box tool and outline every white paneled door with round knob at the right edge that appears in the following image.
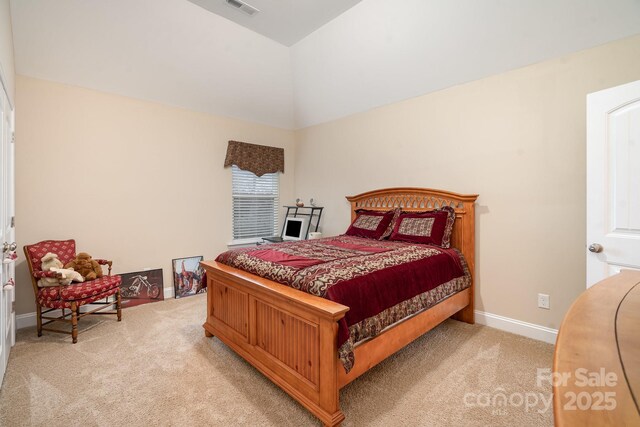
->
[586,81,640,287]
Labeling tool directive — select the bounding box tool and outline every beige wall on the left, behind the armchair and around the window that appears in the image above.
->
[16,76,295,314]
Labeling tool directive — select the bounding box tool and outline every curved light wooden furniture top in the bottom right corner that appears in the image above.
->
[553,270,640,426]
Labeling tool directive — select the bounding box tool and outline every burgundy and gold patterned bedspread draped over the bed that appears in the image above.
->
[216,236,471,372]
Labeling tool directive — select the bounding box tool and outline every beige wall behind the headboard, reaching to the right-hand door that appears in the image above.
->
[295,36,640,328]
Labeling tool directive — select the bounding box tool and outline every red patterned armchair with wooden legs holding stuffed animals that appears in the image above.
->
[24,240,122,344]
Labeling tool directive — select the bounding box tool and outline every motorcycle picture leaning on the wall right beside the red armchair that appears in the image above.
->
[120,268,164,308]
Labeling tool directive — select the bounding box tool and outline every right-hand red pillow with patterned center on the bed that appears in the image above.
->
[389,206,456,248]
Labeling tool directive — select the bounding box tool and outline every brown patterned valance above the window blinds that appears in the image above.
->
[224,141,284,176]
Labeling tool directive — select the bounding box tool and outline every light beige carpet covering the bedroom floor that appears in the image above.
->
[0,295,553,426]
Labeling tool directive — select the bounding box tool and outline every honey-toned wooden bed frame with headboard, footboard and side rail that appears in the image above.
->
[202,188,477,426]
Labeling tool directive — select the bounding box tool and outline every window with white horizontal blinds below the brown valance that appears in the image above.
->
[231,165,279,241]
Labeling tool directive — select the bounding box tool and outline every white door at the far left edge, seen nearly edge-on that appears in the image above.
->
[0,85,16,383]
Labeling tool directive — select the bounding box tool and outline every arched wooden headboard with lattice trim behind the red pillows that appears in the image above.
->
[347,187,478,288]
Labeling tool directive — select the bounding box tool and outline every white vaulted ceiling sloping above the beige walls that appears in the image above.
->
[11,0,640,128]
